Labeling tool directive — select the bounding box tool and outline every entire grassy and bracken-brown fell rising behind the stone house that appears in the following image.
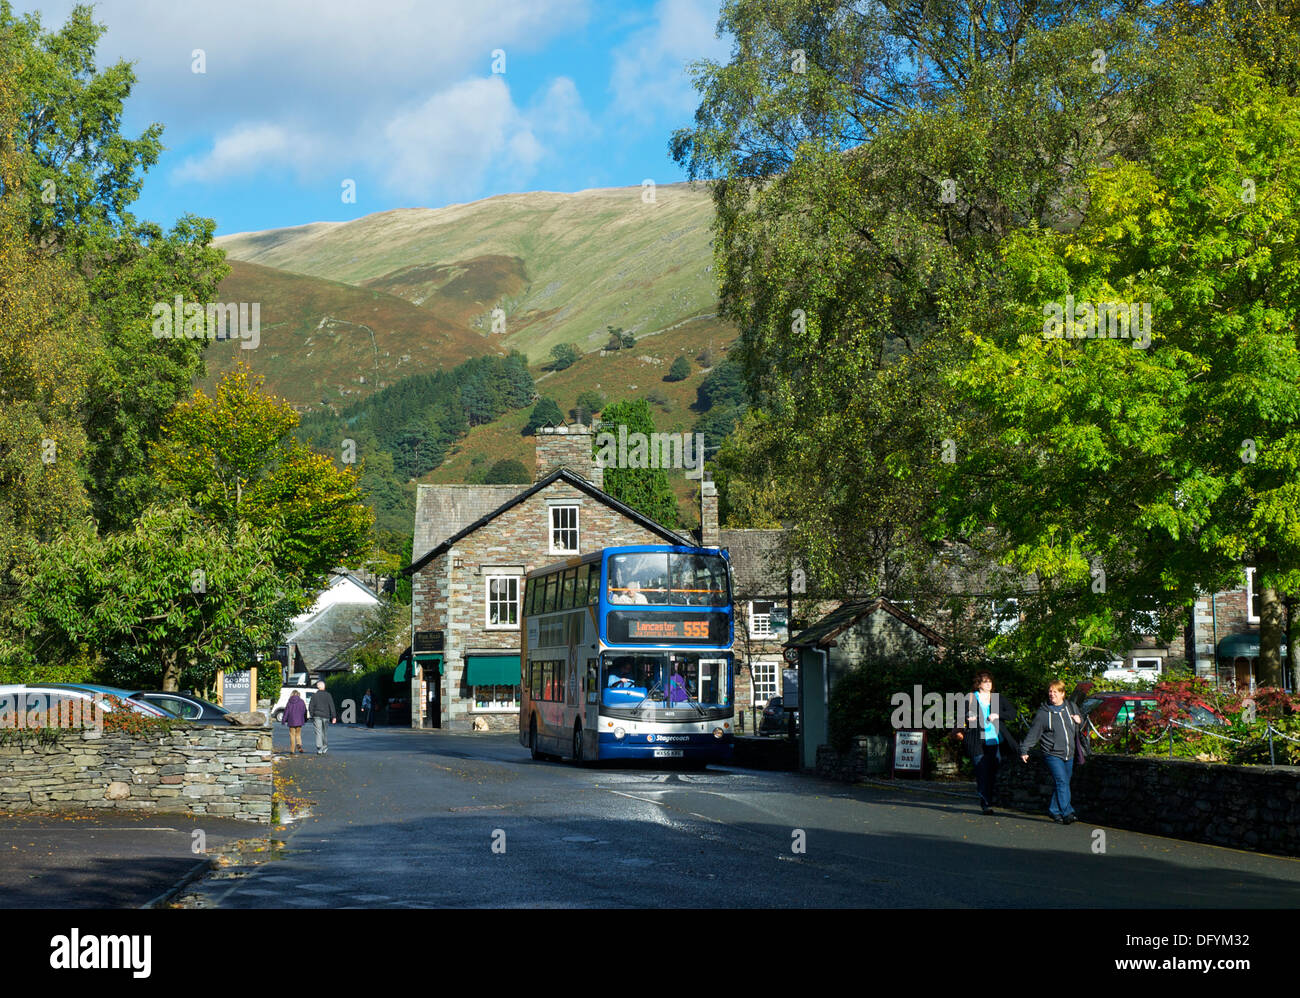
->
[207,185,737,533]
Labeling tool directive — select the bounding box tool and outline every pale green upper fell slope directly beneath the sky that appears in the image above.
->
[217,183,716,363]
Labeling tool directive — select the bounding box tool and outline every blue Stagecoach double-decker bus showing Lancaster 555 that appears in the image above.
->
[519,544,735,764]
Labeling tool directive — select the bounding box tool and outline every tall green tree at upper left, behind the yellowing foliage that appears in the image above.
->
[0,0,228,528]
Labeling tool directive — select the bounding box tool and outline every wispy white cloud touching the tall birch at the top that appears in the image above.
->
[610,0,731,121]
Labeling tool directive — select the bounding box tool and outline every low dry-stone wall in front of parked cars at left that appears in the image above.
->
[0,725,272,823]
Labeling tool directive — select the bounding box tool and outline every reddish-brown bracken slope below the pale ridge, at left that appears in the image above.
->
[202,260,493,409]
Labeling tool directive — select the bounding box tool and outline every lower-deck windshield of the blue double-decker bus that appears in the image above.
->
[601,651,731,715]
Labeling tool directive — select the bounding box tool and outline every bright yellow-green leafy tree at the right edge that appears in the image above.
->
[946,73,1300,685]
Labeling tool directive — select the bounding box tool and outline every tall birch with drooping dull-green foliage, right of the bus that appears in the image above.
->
[672,0,1216,594]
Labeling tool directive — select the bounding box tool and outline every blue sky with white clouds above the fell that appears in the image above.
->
[14,0,731,234]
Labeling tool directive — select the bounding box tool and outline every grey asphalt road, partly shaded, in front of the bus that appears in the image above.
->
[185,725,1300,908]
